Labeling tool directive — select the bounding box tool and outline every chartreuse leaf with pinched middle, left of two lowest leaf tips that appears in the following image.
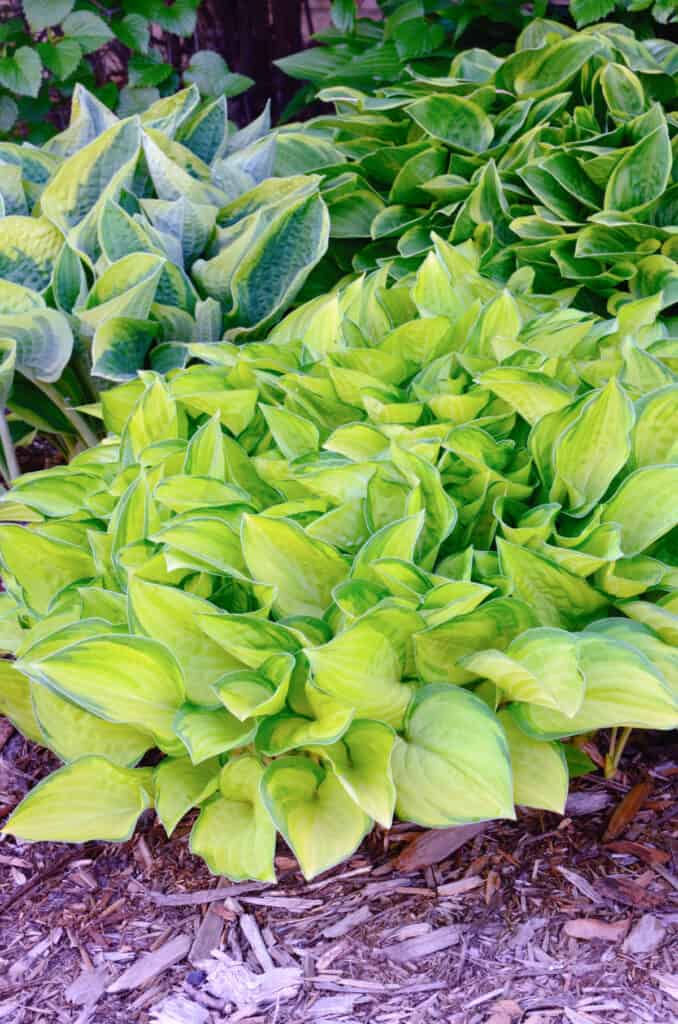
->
[190,755,276,882]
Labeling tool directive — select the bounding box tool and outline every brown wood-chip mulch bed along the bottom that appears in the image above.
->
[0,720,678,1024]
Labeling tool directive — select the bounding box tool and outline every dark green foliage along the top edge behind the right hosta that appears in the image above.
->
[276,0,678,99]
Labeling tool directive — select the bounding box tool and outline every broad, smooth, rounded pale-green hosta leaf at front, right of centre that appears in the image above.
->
[392,685,514,827]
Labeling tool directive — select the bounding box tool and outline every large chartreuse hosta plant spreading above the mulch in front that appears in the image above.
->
[0,239,678,880]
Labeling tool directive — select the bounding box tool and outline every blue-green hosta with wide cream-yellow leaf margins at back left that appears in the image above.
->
[0,84,329,478]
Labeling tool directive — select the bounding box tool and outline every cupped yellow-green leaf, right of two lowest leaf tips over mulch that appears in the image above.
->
[261,757,372,880]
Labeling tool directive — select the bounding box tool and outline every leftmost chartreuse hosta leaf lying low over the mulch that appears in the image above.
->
[2,757,150,843]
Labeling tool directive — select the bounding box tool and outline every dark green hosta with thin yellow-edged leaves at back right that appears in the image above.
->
[280,19,678,303]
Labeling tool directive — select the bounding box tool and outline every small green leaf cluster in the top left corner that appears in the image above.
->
[0,0,253,143]
